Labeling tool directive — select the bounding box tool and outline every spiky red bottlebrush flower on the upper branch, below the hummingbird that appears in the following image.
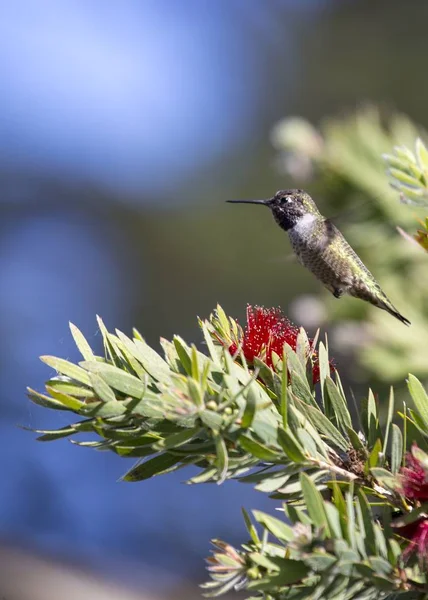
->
[229,305,330,383]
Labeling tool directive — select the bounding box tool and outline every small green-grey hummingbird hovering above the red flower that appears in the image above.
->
[227,190,410,325]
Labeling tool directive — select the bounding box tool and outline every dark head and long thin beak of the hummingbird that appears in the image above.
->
[228,190,320,231]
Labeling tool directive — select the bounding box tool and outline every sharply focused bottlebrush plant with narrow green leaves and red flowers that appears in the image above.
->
[29,306,428,600]
